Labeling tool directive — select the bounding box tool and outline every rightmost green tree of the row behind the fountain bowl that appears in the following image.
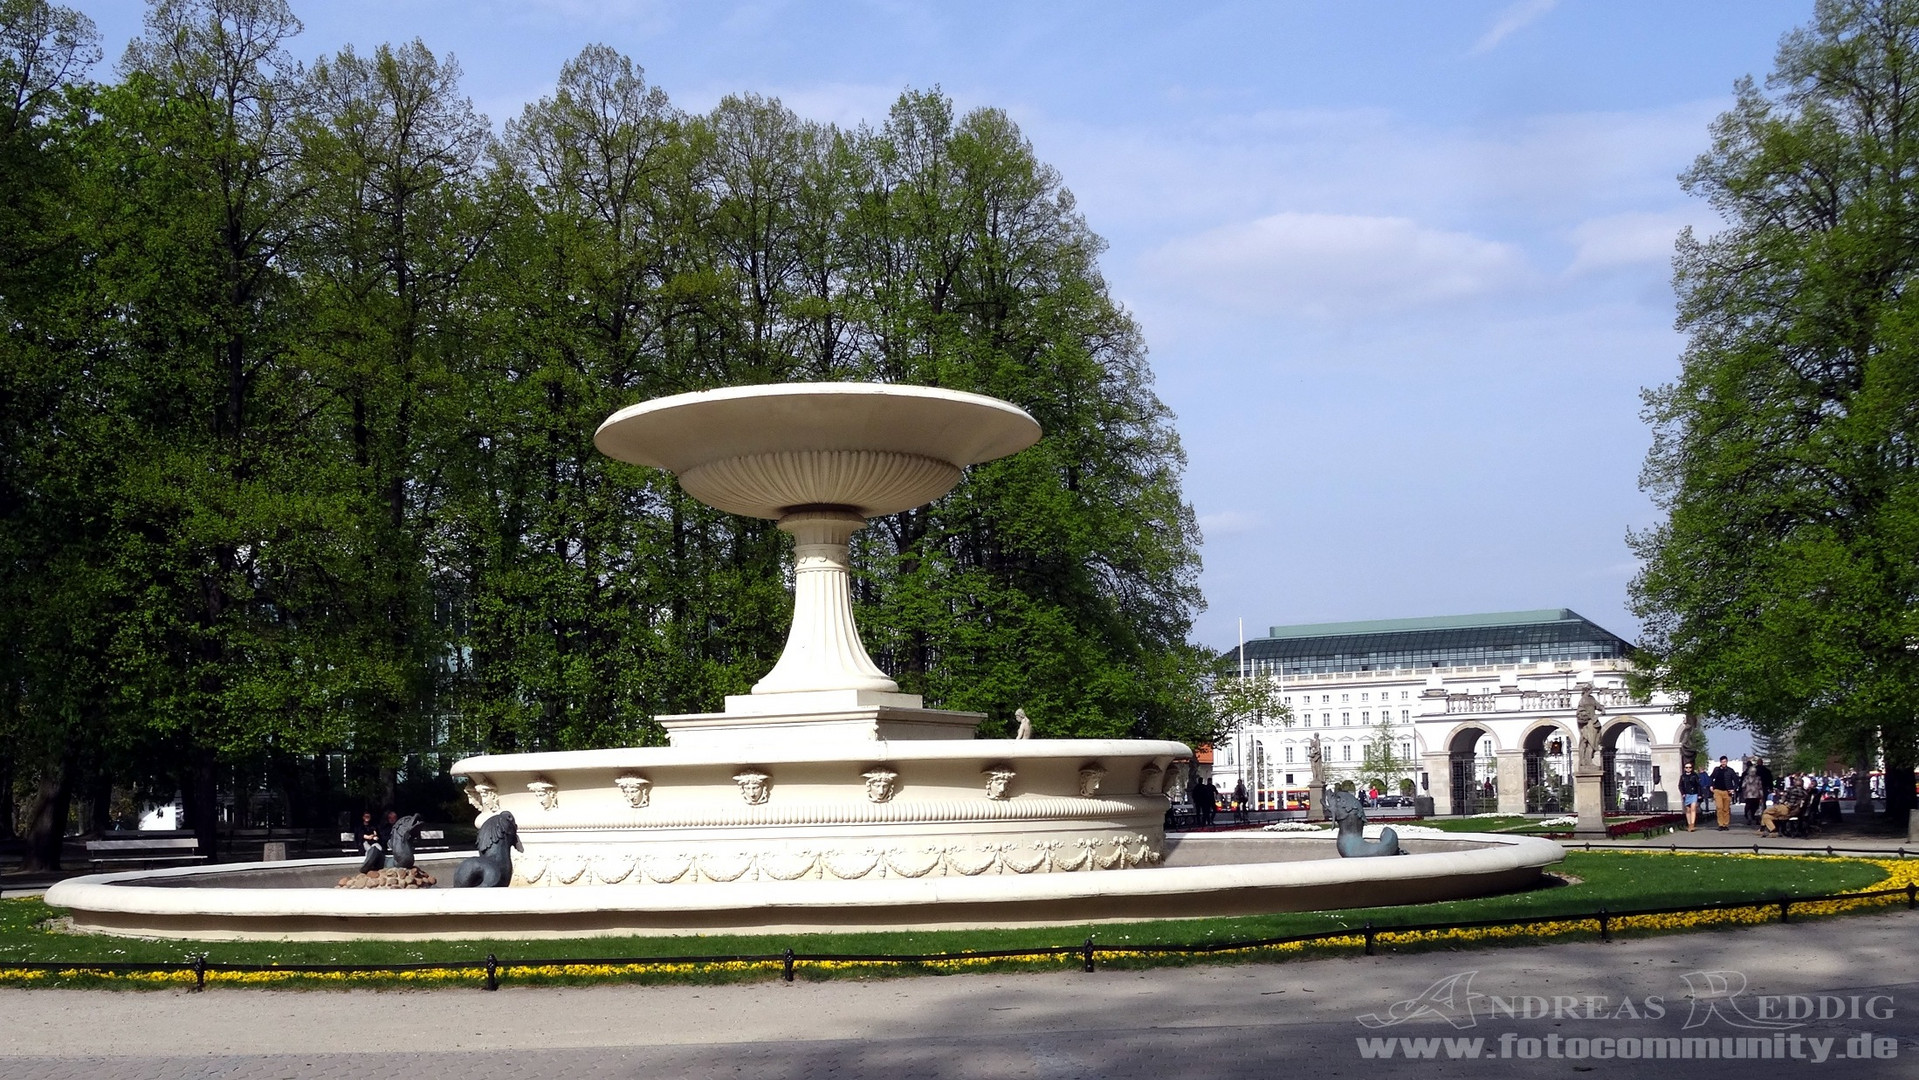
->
[846,92,1213,739]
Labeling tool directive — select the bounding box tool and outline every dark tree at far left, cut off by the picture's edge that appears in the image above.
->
[0,0,115,869]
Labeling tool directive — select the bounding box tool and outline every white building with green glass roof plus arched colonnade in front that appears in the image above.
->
[1213,608,1691,813]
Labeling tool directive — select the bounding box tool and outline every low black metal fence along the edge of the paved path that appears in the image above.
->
[0,884,1919,990]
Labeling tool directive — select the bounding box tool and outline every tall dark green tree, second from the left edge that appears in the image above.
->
[96,0,337,852]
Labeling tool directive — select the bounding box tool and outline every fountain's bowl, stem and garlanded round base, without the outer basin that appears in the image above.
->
[453,384,1190,886]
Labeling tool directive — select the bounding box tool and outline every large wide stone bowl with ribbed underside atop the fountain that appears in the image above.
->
[593,382,1040,520]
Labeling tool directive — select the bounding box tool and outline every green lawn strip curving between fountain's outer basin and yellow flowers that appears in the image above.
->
[0,855,1886,978]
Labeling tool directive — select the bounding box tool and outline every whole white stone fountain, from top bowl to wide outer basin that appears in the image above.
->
[48,384,1562,938]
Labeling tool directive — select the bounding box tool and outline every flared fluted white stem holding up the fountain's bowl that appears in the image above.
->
[752,506,900,694]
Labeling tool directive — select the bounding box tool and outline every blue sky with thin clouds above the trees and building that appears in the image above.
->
[67,0,1812,694]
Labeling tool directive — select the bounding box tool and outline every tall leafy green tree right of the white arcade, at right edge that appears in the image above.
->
[1633,0,1919,821]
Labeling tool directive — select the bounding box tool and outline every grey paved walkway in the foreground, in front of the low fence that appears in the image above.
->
[0,911,1919,1080]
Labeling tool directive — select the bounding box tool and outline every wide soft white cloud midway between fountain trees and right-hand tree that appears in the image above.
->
[1146,213,1526,318]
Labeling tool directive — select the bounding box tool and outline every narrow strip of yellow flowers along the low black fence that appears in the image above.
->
[0,852,1919,988]
